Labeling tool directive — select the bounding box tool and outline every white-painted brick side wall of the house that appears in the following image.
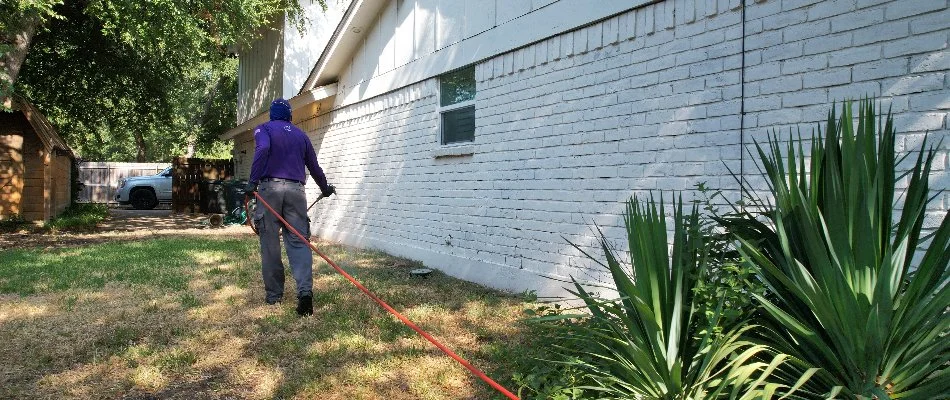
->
[296,0,950,294]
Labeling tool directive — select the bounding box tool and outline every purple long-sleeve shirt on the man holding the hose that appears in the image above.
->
[250,120,330,192]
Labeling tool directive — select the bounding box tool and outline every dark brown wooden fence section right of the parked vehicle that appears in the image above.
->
[172,157,234,213]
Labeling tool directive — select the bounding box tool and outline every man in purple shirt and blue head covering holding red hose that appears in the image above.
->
[246,98,336,316]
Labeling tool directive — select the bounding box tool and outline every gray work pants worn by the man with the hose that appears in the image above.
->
[254,180,313,302]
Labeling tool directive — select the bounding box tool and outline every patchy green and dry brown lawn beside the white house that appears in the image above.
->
[0,235,544,400]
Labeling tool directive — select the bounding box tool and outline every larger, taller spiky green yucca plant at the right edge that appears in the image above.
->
[722,100,950,399]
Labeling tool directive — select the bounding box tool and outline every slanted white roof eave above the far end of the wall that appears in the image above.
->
[300,0,388,93]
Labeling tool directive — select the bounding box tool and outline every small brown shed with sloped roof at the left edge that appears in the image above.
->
[0,100,75,222]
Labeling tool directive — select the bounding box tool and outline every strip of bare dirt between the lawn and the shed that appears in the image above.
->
[0,208,254,250]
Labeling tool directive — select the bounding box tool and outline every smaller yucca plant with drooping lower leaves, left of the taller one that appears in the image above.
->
[559,197,807,399]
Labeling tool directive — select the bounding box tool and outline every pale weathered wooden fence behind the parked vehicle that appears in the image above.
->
[79,162,168,203]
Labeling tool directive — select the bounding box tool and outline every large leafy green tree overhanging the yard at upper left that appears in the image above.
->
[0,0,324,161]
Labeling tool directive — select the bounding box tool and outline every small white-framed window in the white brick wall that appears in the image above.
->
[439,65,475,144]
